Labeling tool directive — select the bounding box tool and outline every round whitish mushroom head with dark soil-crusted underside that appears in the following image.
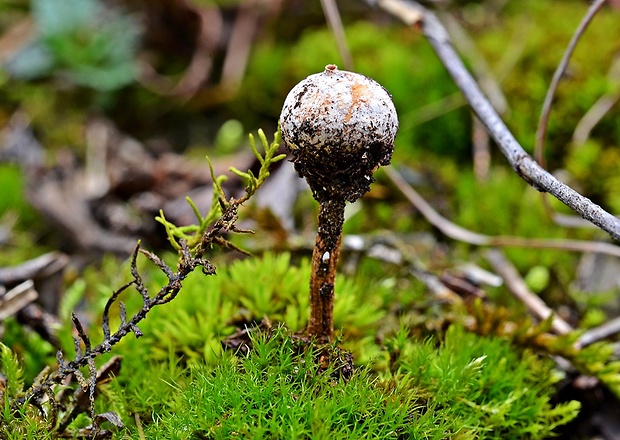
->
[280,64,398,202]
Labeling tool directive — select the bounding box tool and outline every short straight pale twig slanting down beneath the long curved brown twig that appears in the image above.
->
[485,249,572,335]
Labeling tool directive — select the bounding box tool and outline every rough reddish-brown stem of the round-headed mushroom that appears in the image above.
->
[308,198,345,342]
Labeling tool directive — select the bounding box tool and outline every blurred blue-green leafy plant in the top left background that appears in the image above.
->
[6,0,140,92]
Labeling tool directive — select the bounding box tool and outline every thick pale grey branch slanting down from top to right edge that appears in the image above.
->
[376,0,620,240]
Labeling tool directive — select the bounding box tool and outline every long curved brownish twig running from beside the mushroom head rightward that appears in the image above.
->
[384,167,620,257]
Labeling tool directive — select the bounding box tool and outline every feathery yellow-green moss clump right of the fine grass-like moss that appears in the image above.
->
[391,326,580,439]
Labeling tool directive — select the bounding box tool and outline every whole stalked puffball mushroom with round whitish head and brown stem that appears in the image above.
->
[280,64,398,341]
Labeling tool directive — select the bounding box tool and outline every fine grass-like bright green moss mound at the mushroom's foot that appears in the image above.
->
[127,328,447,439]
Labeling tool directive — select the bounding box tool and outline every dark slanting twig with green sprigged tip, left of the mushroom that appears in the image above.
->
[11,142,278,430]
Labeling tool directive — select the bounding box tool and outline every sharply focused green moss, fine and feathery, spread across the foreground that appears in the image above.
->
[106,326,579,439]
